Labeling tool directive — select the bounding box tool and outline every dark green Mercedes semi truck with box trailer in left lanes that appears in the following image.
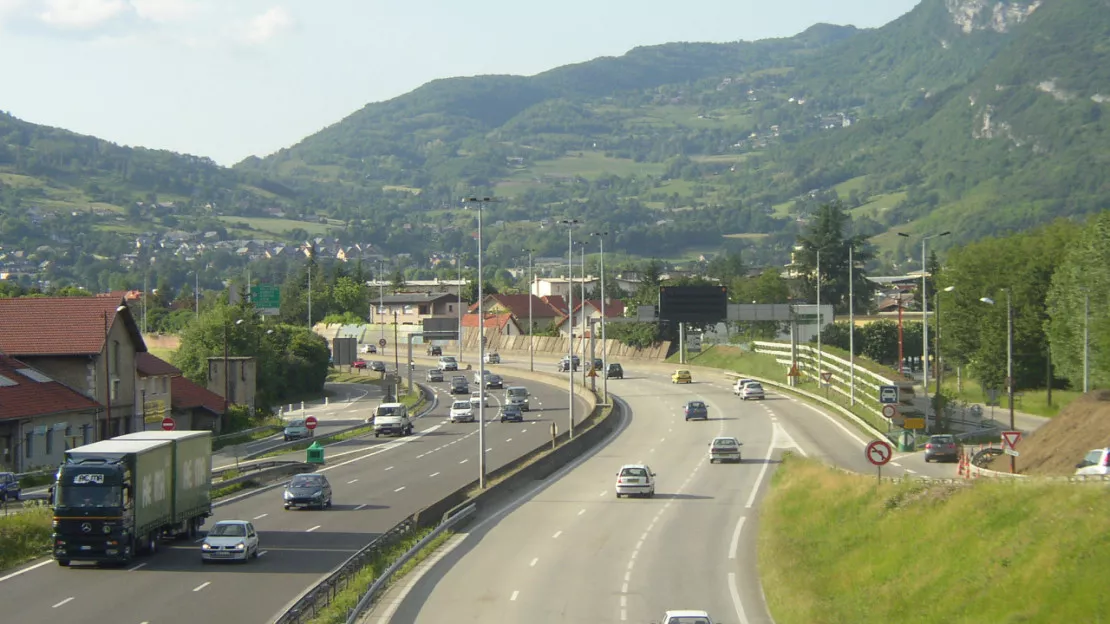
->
[51,431,212,566]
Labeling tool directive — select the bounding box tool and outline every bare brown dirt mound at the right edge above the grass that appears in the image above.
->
[1012,390,1110,476]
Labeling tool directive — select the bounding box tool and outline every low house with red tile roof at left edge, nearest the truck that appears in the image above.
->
[0,353,102,472]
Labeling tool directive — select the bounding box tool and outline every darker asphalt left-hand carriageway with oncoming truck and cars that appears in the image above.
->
[0,361,584,624]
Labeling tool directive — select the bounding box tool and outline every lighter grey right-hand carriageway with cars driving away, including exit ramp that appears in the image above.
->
[377,353,955,624]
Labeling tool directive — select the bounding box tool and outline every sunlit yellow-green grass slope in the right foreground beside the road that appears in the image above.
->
[758,455,1110,624]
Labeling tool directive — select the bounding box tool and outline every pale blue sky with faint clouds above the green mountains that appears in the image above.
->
[0,0,919,165]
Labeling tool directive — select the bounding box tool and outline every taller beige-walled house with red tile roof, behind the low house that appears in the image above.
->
[0,293,147,440]
